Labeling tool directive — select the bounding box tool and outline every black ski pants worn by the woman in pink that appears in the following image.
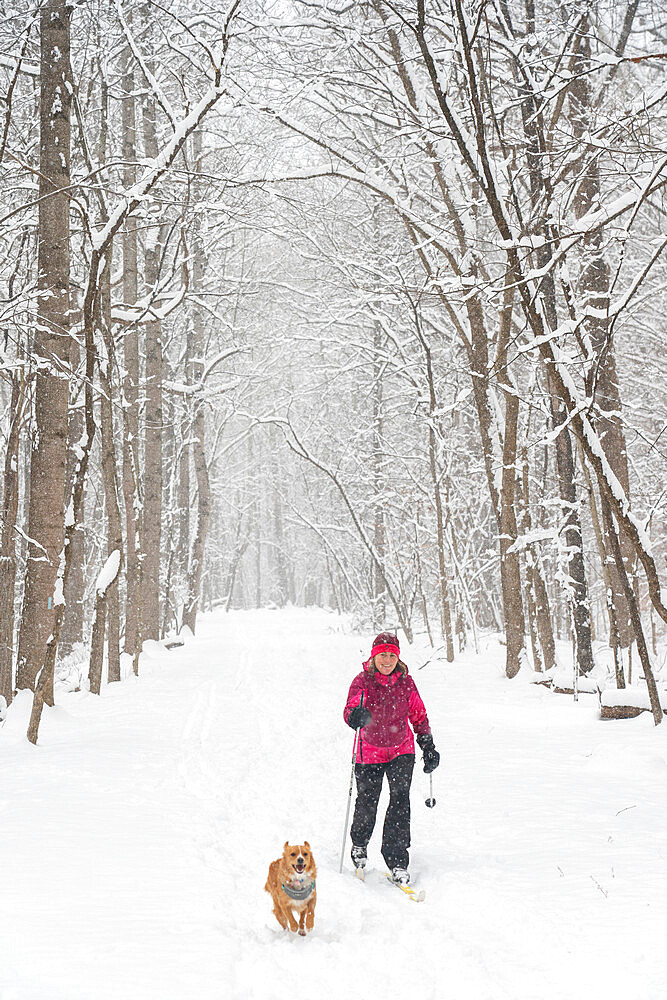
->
[350,753,415,868]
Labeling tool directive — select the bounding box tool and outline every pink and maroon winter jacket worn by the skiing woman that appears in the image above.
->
[343,663,431,764]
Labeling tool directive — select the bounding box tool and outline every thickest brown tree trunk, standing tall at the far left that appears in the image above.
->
[17,0,72,704]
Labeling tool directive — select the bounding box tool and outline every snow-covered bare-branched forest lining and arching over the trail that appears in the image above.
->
[0,0,667,742]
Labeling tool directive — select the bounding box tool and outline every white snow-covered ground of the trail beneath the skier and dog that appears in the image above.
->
[0,610,667,1000]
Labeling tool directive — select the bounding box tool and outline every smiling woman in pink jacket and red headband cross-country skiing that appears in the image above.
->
[343,632,440,885]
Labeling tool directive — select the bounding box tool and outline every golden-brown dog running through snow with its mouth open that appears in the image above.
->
[264,841,317,937]
